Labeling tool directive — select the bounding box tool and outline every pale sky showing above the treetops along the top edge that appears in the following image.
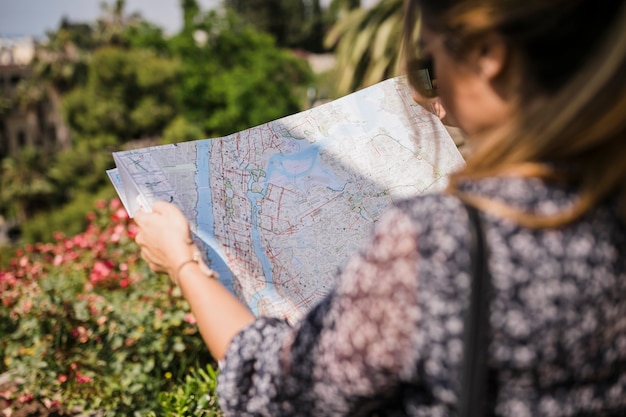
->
[0,0,376,38]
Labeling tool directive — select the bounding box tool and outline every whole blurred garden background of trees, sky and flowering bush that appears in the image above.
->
[0,0,424,417]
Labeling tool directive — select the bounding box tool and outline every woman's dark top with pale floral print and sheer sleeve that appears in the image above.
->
[218,178,626,417]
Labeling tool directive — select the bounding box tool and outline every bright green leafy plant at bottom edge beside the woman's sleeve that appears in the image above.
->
[154,365,222,417]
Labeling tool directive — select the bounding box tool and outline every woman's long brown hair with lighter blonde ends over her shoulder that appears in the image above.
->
[404,0,626,227]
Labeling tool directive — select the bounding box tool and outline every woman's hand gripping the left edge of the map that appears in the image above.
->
[135,201,197,280]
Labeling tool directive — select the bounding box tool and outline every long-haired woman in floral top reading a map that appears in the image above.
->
[136,0,626,416]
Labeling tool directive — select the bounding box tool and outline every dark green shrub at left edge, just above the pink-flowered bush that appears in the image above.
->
[0,135,122,243]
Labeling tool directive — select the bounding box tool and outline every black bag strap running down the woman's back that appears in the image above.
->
[459,204,491,417]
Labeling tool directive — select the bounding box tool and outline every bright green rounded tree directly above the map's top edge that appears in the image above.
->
[171,11,312,136]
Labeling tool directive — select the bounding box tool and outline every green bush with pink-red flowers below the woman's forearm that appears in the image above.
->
[0,199,215,416]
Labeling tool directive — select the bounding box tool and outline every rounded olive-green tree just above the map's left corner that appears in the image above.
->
[63,47,179,141]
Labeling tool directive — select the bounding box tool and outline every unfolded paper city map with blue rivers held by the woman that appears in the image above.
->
[108,77,464,322]
